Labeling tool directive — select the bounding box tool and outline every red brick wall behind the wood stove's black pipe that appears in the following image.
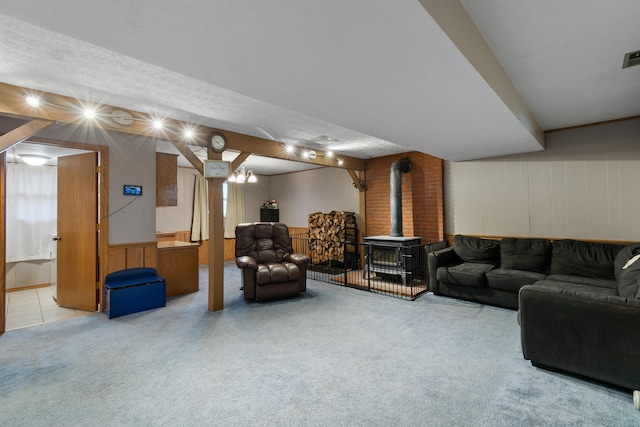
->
[365,151,444,242]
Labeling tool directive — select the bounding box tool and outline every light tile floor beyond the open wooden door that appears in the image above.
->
[6,286,93,331]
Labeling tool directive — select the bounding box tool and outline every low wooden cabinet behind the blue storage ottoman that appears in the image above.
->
[158,241,199,297]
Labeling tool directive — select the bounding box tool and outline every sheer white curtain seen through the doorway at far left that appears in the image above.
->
[6,163,58,262]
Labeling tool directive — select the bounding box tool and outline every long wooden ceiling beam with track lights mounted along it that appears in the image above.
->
[0,83,365,170]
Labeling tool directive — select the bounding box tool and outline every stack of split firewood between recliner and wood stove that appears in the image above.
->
[309,211,357,263]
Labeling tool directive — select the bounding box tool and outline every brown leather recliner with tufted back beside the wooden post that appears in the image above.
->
[235,222,311,301]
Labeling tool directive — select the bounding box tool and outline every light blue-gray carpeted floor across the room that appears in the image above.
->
[0,263,640,426]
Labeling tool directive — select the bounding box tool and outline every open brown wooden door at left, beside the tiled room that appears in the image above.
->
[57,152,98,311]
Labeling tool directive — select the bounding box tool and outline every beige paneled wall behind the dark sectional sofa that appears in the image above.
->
[445,119,640,240]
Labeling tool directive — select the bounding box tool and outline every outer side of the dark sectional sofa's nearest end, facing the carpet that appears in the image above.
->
[518,284,640,389]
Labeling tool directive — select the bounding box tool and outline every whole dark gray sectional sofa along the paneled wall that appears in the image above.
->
[427,236,640,398]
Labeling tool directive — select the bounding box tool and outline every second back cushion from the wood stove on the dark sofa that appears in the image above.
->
[500,237,551,273]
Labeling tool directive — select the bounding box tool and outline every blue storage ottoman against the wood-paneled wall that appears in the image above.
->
[103,268,167,319]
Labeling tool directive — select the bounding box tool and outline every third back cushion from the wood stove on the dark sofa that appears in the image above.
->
[551,239,624,280]
